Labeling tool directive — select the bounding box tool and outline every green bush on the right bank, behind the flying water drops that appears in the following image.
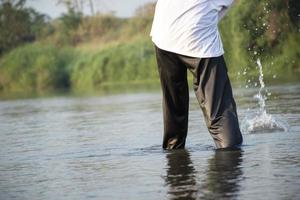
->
[220,0,300,78]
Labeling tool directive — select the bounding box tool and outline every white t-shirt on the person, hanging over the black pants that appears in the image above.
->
[150,0,233,58]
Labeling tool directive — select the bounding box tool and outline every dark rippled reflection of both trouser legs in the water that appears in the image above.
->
[165,149,243,200]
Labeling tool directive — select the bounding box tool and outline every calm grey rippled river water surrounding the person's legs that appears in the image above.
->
[0,84,300,200]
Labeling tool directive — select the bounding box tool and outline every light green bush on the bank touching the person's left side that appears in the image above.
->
[71,39,157,90]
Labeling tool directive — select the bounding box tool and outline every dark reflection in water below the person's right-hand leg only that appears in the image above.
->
[199,149,243,199]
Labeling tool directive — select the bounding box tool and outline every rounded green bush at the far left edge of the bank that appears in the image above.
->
[0,44,73,92]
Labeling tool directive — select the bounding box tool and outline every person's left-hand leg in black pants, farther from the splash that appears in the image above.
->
[156,47,189,149]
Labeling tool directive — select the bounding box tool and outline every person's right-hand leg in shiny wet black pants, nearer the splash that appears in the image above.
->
[192,56,243,148]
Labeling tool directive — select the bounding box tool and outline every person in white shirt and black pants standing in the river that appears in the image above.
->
[150,0,243,149]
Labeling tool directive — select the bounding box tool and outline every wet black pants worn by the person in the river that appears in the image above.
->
[156,47,243,149]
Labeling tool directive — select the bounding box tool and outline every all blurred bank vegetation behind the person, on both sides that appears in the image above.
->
[0,0,300,93]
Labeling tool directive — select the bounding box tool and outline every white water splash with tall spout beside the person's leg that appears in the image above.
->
[242,59,288,133]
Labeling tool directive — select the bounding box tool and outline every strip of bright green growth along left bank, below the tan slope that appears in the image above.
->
[0,38,157,93]
